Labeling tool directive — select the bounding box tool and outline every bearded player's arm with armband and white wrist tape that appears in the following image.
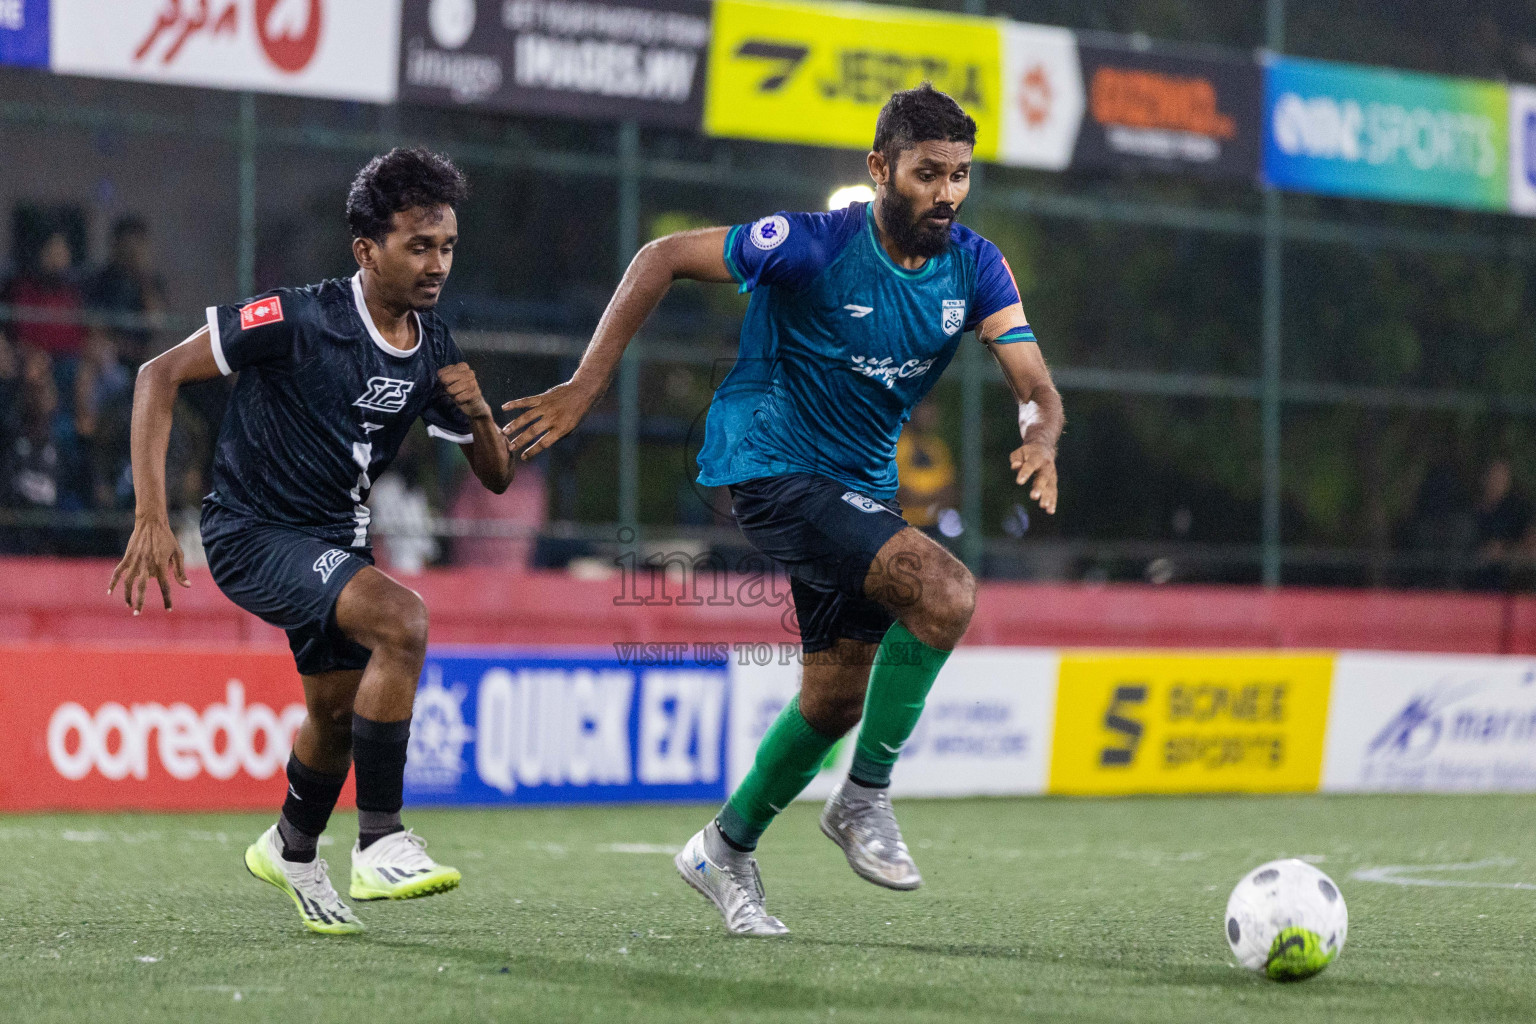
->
[977,302,1066,514]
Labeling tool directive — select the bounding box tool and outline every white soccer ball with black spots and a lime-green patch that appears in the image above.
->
[1227,860,1349,981]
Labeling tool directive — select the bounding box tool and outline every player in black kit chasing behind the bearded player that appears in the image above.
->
[109,149,513,935]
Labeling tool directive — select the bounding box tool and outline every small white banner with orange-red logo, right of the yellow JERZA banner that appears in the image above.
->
[998,21,1083,170]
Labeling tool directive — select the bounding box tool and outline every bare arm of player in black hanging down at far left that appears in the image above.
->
[106,327,220,616]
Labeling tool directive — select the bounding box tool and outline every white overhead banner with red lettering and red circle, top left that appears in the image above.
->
[50,0,399,103]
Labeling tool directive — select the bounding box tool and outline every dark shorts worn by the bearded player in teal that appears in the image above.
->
[731,473,906,654]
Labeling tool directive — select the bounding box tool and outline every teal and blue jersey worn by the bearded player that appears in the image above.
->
[699,203,1018,500]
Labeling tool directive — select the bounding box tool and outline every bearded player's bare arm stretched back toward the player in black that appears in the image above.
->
[502,227,734,459]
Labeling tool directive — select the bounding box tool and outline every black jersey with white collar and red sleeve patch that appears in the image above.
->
[207,272,473,548]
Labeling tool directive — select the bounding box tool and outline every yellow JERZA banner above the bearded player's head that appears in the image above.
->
[703,0,1003,160]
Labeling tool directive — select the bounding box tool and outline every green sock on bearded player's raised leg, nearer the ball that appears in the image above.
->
[848,622,949,786]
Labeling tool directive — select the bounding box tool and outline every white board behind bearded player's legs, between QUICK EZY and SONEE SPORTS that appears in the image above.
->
[728,648,1057,800]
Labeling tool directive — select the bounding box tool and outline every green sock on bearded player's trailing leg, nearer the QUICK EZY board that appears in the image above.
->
[717,695,839,851]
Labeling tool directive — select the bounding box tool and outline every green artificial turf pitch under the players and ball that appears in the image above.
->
[0,797,1536,1024]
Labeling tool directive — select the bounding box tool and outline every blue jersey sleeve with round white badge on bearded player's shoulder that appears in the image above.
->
[725,203,863,292]
